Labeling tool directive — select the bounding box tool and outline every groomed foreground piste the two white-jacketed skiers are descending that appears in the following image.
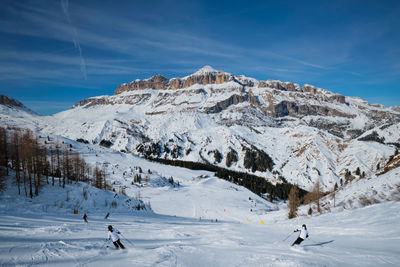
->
[0,202,400,266]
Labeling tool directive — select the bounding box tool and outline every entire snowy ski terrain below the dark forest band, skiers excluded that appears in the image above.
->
[0,118,400,266]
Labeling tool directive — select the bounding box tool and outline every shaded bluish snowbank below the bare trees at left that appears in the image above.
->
[0,173,152,218]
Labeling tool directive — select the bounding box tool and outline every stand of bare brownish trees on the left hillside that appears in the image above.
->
[0,127,108,198]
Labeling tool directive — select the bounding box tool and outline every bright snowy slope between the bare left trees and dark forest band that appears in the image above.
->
[40,138,278,223]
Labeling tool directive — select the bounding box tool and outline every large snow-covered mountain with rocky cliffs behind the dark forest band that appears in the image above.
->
[1,66,400,193]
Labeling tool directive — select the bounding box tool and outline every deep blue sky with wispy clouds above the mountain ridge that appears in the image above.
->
[0,0,400,114]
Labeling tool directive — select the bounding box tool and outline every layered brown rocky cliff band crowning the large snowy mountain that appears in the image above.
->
[74,66,400,138]
